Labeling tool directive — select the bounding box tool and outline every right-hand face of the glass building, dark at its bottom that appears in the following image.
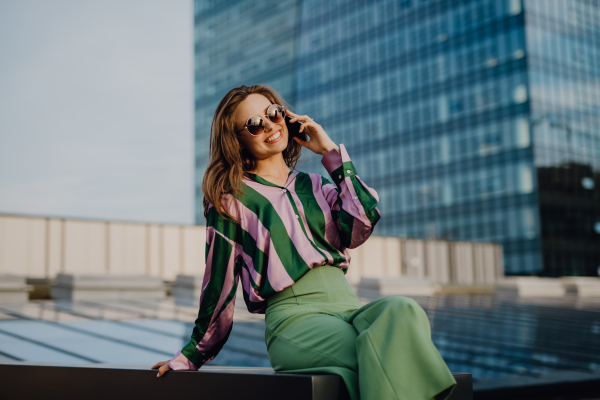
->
[525,0,600,275]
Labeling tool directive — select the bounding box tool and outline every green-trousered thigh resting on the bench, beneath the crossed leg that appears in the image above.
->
[265,305,358,371]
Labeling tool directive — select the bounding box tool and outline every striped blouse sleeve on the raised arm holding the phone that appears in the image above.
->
[321,144,381,249]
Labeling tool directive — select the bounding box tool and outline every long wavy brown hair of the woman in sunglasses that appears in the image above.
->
[202,84,302,222]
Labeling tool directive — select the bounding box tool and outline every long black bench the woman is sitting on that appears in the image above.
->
[0,361,473,400]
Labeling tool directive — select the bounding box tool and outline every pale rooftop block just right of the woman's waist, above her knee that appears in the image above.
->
[356,277,439,296]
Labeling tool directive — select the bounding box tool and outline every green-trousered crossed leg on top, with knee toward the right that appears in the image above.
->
[345,296,456,400]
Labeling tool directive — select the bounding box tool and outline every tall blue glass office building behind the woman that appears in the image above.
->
[195,0,600,276]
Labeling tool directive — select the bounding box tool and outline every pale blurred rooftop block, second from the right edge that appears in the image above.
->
[496,276,565,297]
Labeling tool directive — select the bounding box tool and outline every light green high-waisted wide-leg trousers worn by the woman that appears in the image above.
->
[265,266,456,400]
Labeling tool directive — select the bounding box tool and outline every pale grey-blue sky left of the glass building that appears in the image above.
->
[0,0,194,224]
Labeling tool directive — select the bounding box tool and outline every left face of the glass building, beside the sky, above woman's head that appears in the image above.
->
[194,0,299,224]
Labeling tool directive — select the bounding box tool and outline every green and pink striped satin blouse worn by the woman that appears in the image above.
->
[169,144,381,370]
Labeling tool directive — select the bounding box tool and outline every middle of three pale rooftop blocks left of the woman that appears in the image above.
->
[51,273,166,301]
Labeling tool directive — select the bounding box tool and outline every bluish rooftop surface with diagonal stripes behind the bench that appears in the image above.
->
[0,293,600,391]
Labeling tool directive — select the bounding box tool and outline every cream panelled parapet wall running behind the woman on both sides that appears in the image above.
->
[0,215,504,287]
